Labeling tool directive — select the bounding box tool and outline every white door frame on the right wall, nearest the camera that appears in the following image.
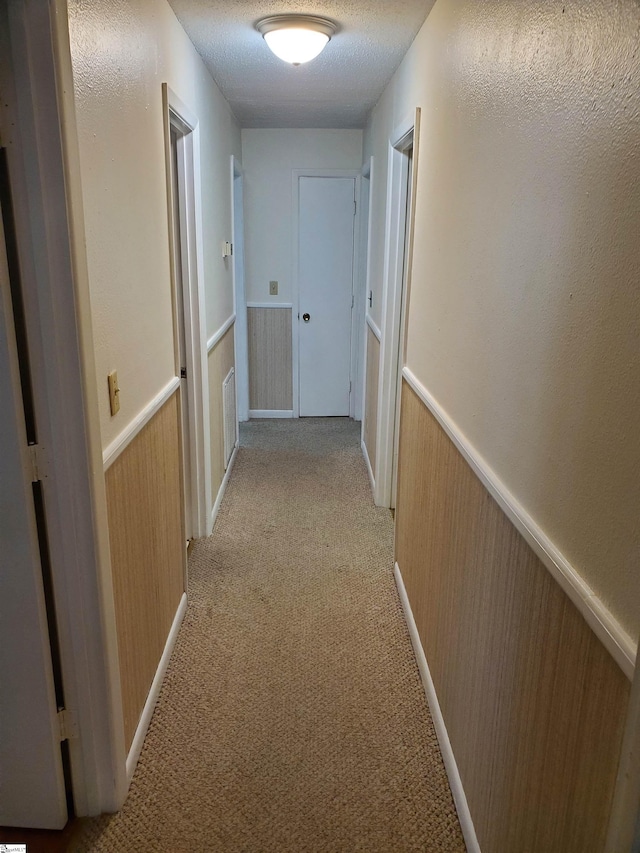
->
[374,109,420,507]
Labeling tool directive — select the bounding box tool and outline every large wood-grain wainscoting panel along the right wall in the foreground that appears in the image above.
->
[396,381,629,853]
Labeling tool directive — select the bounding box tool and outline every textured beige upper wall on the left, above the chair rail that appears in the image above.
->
[69,0,240,447]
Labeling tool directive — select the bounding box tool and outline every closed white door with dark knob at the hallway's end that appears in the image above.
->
[298,177,355,417]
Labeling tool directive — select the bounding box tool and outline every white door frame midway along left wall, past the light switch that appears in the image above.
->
[162,83,212,536]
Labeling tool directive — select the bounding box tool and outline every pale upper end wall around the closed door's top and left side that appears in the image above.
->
[242,129,362,302]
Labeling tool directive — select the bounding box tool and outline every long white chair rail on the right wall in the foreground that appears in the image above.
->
[402,367,637,680]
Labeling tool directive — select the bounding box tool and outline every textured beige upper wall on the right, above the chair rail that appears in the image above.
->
[365,0,640,639]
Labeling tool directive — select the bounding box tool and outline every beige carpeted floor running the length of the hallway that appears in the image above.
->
[73,419,465,853]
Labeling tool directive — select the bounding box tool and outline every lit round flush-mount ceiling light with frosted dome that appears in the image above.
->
[256,15,336,65]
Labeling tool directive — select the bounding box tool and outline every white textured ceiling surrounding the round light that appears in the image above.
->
[169,0,434,128]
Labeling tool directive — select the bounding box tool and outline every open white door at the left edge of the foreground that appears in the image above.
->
[0,191,67,829]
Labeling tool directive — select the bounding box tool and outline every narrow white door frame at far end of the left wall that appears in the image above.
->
[231,154,249,421]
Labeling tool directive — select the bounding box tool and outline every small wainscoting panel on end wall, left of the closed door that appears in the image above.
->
[247,308,293,411]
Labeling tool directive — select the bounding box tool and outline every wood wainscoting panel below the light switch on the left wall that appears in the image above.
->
[105,389,186,750]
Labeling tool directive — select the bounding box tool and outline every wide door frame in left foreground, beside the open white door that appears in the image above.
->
[4,0,127,816]
